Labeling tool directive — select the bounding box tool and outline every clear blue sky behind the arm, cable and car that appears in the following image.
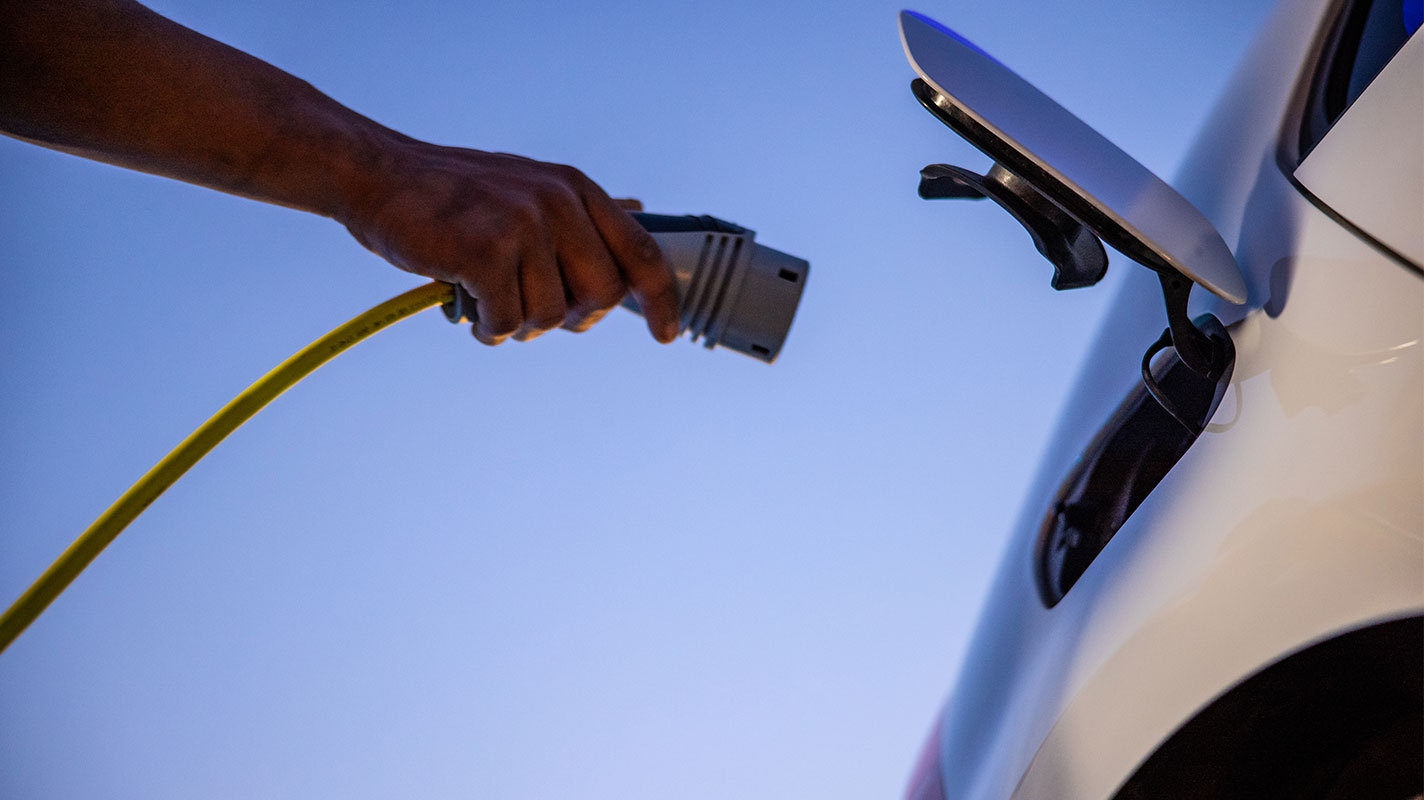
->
[0,0,1267,800]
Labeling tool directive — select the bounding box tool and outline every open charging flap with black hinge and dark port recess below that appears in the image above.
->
[900,11,1246,597]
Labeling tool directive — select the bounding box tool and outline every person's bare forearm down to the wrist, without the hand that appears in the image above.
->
[0,0,390,218]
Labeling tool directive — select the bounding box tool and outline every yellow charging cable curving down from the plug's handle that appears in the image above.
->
[0,280,454,653]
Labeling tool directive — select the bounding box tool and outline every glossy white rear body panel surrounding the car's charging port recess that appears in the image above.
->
[922,0,1424,799]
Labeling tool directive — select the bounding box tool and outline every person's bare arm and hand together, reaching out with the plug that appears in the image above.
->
[0,0,678,344]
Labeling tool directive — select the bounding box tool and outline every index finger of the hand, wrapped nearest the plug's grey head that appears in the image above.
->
[584,191,682,343]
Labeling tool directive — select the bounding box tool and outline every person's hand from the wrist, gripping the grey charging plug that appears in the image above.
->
[337,140,679,344]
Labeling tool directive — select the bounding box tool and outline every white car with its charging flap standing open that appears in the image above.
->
[901,0,1424,800]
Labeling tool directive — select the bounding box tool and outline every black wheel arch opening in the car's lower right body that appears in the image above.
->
[1114,616,1424,800]
